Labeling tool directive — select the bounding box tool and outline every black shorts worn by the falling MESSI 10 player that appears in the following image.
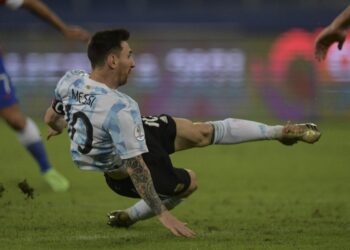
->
[105,115,191,199]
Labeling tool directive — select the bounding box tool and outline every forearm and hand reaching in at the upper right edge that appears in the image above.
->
[315,5,350,61]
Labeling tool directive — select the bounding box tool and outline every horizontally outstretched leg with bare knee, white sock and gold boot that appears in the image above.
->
[174,118,321,151]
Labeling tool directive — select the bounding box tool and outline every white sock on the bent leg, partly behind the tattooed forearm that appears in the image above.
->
[126,197,182,221]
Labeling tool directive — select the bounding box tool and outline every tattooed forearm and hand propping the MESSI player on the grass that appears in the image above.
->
[125,155,194,237]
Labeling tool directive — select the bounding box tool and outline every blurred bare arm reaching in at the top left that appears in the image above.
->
[21,0,90,41]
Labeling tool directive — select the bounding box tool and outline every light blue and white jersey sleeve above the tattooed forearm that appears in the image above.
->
[107,102,148,159]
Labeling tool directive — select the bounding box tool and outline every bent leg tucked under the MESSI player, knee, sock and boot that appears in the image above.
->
[107,169,197,227]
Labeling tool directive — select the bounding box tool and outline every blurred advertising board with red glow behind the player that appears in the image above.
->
[1,26,350,121]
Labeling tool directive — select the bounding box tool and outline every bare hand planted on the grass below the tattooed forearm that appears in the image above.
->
[158,211,196,238]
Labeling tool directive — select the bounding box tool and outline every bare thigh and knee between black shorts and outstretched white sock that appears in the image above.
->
[174,117,214,151]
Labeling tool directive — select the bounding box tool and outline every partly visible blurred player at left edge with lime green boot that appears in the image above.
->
[0,0,90,191]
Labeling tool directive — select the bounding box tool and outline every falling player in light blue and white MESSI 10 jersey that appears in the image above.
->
[45,29,320,237]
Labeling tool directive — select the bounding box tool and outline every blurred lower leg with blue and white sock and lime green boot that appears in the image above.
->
[0,104,69,191]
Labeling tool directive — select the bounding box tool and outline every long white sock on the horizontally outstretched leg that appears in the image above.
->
[209,118,283,144]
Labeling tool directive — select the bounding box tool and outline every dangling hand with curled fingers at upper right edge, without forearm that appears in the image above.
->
[315,26,346,61]
